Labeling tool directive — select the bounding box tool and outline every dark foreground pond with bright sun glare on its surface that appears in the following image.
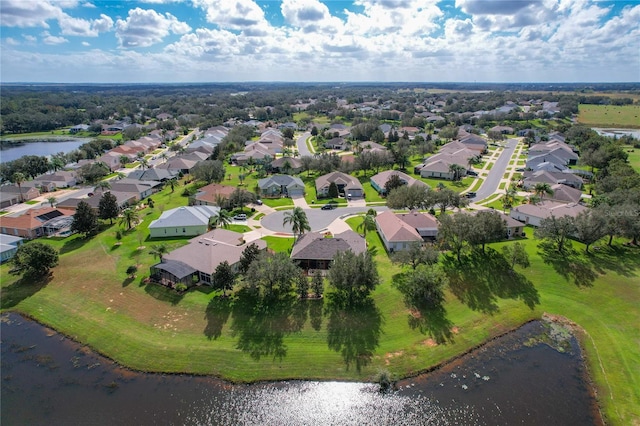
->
[1,314,602,425]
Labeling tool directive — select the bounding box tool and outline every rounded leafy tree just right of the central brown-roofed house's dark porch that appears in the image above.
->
[328,250,380,305]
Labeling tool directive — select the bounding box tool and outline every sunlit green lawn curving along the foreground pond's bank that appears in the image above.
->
[0,199,640,424]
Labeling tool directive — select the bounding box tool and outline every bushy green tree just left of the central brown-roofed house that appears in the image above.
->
[244,252,299,296]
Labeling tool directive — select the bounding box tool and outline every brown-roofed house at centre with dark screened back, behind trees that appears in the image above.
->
[291,230,367,271]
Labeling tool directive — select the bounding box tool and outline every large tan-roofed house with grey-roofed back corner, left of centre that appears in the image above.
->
[151,229,267,287]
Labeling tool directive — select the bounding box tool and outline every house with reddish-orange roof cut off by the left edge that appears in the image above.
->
[0,207,73,239]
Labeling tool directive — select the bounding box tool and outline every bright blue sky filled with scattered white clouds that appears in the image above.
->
[0,0,640,83]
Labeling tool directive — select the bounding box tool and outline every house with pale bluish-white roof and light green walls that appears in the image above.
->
[149,206,220,238]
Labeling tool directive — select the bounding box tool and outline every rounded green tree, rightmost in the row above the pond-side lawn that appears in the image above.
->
[394,265,449,309]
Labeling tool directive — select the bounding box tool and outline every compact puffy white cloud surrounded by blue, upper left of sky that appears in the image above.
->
[116,7,191,48]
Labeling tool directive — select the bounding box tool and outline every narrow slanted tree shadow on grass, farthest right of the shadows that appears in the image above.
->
[538,241,598,287]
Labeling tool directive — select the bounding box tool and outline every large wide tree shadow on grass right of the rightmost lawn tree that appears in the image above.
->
[443,248,540,314]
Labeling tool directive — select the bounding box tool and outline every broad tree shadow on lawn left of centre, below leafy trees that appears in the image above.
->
[231,288,306,360]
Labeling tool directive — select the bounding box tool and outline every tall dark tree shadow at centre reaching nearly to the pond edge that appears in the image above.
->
[327,294,383,372]
